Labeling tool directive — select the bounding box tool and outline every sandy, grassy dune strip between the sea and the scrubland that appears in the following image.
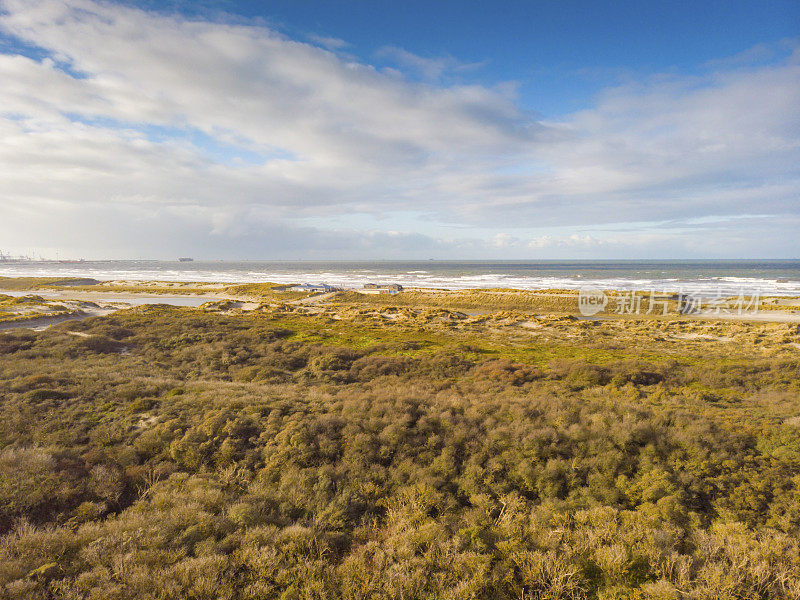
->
[0,278,800,330]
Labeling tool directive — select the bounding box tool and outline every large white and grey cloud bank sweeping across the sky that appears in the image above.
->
[0,0,800,256]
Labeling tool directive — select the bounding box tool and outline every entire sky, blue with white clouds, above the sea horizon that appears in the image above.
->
[0,0,800,260]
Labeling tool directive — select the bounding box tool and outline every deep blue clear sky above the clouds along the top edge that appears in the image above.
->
[126,0,800,117]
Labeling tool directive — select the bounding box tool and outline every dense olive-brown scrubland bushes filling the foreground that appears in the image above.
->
[0,290,800,600]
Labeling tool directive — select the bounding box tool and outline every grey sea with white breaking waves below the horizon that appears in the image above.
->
[0,260,800,296]
